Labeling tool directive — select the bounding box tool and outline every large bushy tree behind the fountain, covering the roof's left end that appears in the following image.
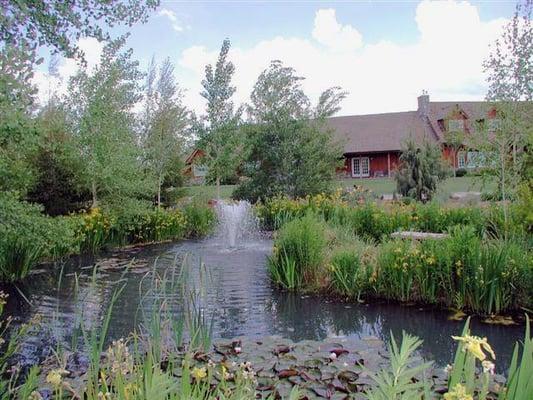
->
[234,61,344,202]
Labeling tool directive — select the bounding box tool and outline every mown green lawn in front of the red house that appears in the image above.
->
[183,176,493,202]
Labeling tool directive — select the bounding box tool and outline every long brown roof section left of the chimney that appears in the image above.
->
[328,111,437,153]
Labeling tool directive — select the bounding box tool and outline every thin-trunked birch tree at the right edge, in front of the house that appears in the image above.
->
[473,0,533,230]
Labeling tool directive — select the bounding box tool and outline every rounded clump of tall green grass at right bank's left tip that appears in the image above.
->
[268,214,326,289]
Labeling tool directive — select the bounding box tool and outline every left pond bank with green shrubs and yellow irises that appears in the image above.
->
[0,194,216,282]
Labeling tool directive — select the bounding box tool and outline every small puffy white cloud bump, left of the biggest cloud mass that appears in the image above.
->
[313,8,363,51]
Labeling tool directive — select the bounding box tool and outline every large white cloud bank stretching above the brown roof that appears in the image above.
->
[179,0,505,115]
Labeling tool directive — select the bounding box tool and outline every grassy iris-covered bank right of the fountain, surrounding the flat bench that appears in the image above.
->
[266,195,533,315]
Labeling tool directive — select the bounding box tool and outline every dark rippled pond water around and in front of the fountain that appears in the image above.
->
[1,234,524,372]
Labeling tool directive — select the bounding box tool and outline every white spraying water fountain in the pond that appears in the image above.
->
[216,200,257,249]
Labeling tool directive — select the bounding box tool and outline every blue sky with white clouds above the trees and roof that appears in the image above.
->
[35,0,515,115]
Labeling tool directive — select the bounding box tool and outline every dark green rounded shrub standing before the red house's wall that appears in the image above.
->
[395,141,446,202]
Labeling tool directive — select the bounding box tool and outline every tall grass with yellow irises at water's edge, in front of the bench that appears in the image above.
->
[268,214,533,315]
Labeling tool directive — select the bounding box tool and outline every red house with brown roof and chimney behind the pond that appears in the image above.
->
[328,93,498,178]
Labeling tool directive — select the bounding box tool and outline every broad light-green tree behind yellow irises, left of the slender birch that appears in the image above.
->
[69,40,150,207]
